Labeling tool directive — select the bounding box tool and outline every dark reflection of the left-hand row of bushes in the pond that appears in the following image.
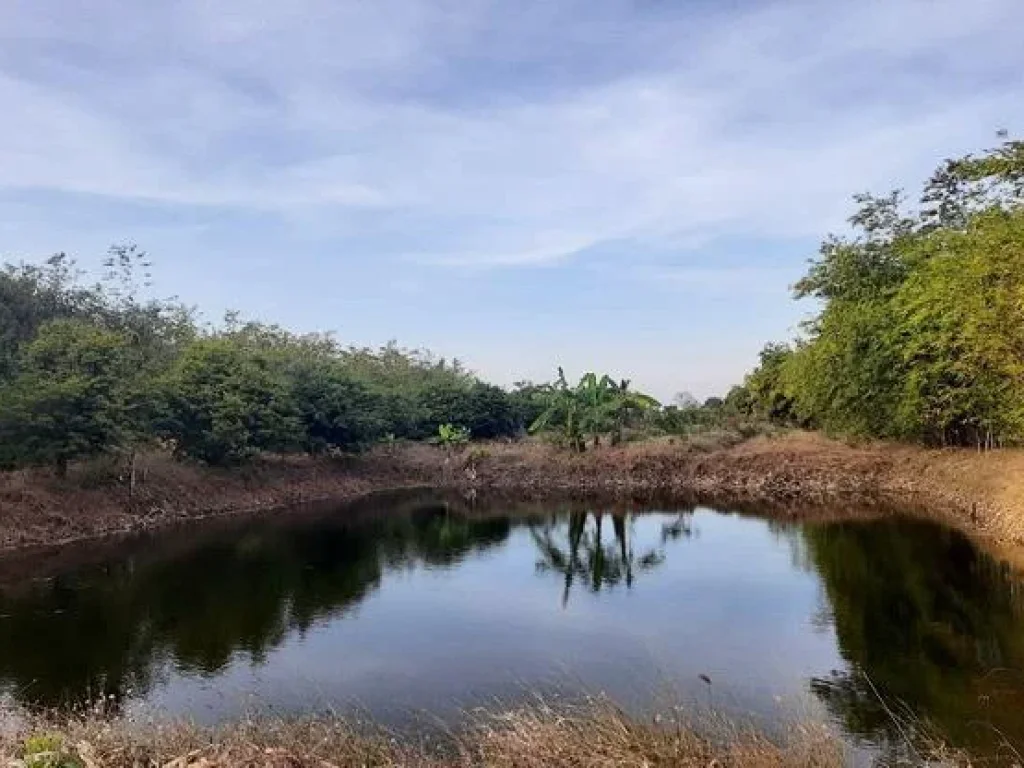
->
[0,498,511,708]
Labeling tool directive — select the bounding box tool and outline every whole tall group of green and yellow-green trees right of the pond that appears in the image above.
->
[744,141,1024,447]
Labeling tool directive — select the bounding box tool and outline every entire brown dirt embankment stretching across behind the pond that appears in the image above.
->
[0,433,1024,549]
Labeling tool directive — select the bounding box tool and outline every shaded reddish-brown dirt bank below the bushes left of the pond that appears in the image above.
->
[0,446,442,551]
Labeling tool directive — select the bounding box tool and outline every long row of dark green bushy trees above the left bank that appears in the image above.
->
[0,246,545,471]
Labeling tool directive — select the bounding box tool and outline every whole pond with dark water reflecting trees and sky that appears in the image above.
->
[0,494,1024,753]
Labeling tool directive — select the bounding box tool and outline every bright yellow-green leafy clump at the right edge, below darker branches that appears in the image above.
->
[895,210,1024,446]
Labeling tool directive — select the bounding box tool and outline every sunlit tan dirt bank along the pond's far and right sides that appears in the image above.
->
[460,432,1024,546]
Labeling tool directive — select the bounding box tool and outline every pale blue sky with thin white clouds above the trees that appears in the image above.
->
[0,0,1024,399]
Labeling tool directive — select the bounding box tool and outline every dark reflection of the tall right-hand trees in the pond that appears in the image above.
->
[803,521,1024,757]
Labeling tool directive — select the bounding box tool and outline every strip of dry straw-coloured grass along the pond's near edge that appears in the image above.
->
[0,701,880,768]
